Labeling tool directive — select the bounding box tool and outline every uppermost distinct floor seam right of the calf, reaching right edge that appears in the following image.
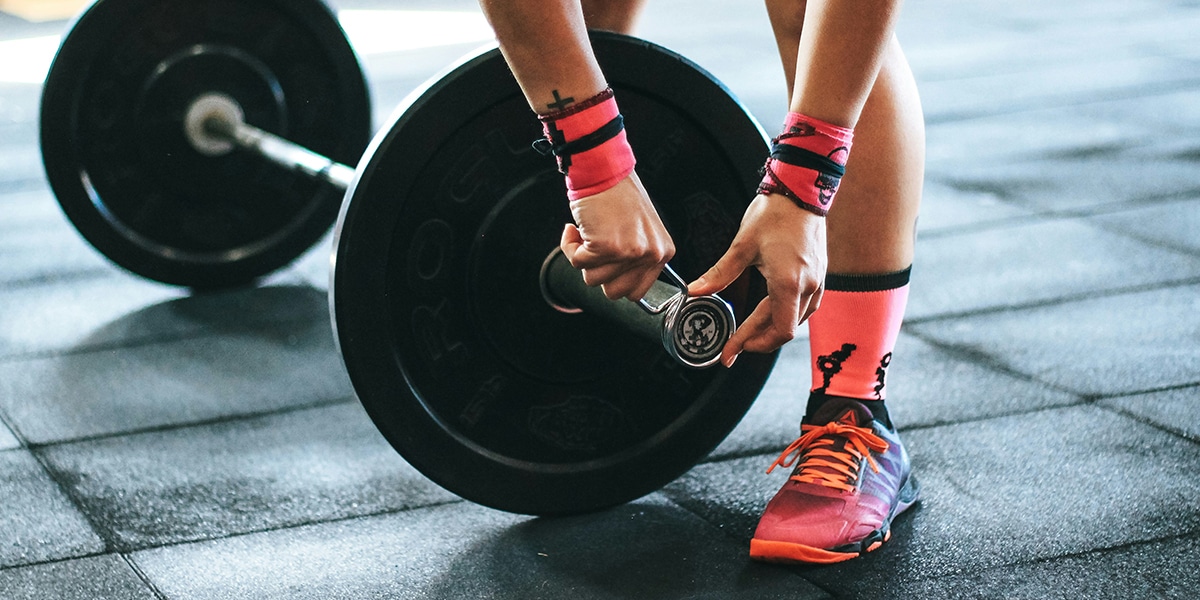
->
[918,77,1200,126]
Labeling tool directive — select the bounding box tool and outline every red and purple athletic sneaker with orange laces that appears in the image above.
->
[750,397,918,563]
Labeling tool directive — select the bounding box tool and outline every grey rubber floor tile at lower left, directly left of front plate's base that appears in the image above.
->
[42,403,455,550]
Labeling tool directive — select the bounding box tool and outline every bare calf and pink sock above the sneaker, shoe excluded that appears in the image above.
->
[809,38,925,405]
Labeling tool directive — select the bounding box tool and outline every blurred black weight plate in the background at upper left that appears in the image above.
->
[41,0,371,288]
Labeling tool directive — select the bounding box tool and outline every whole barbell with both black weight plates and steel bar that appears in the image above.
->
[42,0,775,515]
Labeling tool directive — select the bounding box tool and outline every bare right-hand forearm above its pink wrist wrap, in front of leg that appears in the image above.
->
[767,0,901,127]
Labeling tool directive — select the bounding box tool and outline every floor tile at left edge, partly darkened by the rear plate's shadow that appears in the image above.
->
[0,278,329,356]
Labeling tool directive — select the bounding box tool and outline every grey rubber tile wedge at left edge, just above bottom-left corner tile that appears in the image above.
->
[0,450,104,566]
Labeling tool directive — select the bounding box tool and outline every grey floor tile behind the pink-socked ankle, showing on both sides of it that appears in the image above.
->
[713,332,1079,458]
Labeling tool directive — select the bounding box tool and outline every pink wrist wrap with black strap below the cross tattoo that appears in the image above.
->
[533,88,636,200]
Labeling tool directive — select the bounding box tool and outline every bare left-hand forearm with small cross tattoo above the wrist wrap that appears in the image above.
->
[479,0,607,114]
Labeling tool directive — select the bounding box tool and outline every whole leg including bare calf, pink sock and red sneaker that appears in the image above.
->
[751,0,924,563]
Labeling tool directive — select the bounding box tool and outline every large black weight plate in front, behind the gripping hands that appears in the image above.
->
[330,34,775,515]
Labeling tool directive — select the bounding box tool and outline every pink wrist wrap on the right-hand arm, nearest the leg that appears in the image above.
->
[758,113,854,216]
